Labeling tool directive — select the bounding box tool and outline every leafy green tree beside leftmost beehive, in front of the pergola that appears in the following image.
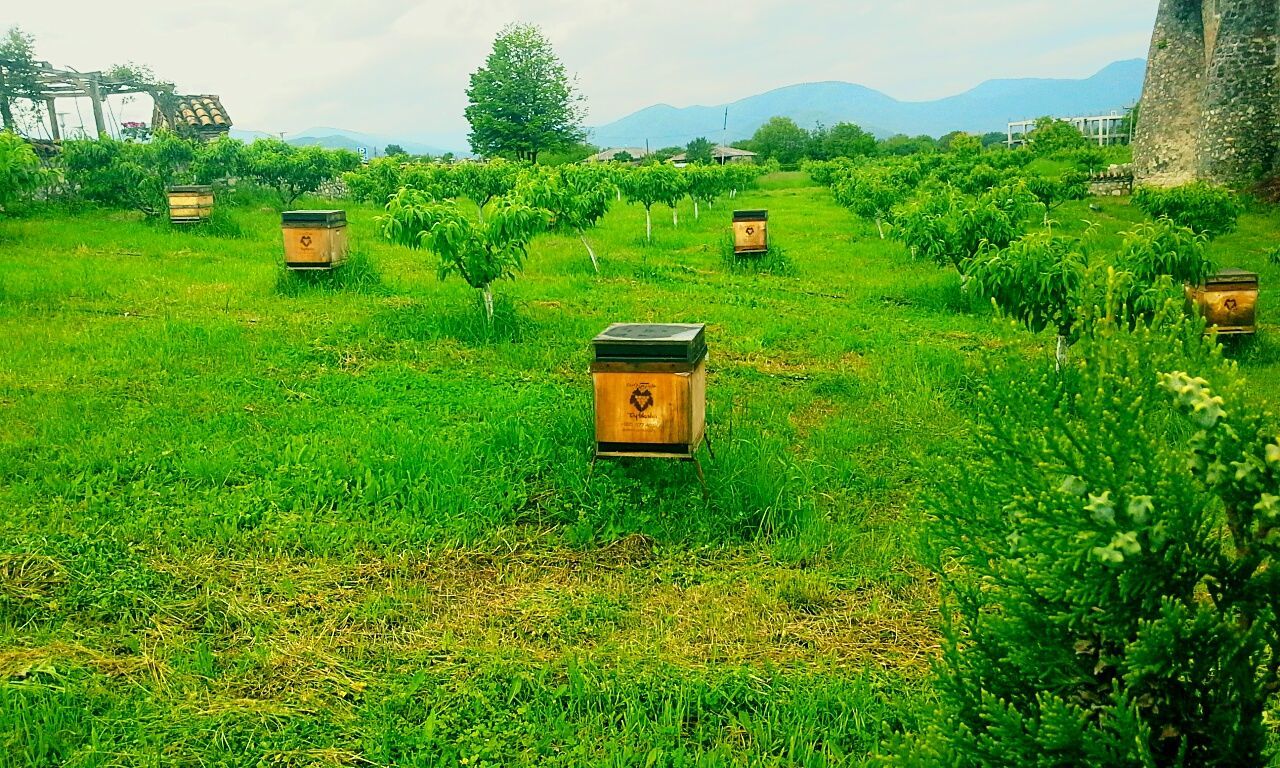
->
[60,132,196,218]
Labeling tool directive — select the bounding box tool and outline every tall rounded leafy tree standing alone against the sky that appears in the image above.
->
[466,24,586,163]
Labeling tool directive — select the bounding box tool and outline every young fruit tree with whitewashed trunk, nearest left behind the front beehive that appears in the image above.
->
[380,189,548,324]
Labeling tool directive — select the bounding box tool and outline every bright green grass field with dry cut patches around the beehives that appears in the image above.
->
[0,174,1280,767]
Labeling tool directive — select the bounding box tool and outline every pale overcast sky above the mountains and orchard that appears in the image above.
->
[0,0,1158,148]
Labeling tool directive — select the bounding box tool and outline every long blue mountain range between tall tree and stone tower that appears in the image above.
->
[590,59,1147,148]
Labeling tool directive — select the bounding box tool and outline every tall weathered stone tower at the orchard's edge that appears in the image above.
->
[1134,0,1280,186]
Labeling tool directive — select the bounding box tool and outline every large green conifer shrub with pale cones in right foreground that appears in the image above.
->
[897,311,1280,768]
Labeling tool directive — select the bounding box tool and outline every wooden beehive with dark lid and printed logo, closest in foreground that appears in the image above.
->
[591,323,707,458]
